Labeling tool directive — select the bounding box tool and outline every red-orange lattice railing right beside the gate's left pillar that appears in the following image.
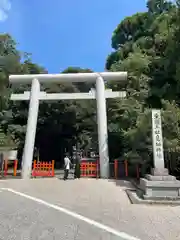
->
[32,160,54,177]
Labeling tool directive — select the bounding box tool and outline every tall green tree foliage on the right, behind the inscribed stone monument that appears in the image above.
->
[106,0,180,162]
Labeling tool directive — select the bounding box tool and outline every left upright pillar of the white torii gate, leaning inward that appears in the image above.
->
[22,79,40,179]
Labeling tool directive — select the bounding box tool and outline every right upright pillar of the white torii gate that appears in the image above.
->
[96,75,109,178]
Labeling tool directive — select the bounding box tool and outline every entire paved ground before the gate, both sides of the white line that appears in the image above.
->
[0,179,180,240]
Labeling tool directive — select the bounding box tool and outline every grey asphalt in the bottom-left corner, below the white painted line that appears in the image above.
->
[0,189,119,240]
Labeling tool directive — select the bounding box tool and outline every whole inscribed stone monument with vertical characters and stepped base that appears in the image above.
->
[138,109,180,200]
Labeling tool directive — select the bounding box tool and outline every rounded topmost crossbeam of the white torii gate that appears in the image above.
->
[9,72,127,84]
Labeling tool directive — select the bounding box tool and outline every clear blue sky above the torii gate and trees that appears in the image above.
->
[0,0,146,73]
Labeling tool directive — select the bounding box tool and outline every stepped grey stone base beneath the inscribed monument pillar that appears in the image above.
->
[137,168,180,200]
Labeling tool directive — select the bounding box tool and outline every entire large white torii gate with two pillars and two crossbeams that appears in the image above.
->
[9,72,127,179]
